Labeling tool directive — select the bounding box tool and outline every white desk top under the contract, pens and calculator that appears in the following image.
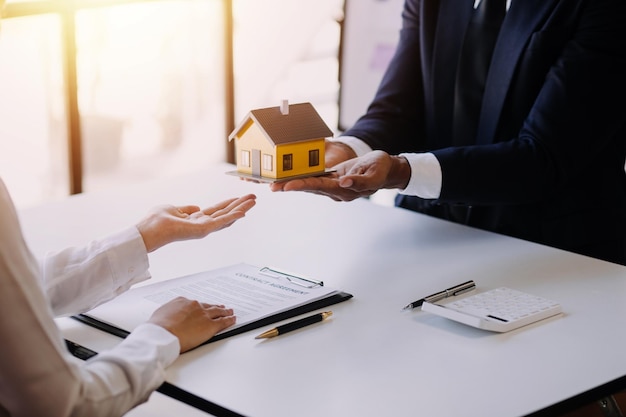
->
[21,166,626,417]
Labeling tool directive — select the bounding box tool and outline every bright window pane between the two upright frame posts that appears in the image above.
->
[76,0,226,191]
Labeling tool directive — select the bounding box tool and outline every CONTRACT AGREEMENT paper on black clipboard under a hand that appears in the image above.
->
[73,263,352,341]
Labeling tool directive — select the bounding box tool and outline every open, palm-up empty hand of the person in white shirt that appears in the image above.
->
[137,194,256,252]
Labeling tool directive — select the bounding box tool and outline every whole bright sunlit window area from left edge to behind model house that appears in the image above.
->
[0,0,343,207]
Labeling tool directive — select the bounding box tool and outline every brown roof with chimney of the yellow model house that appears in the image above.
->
[228,103,333,145]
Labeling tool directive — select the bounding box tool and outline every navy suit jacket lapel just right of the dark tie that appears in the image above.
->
[478,0,558,144]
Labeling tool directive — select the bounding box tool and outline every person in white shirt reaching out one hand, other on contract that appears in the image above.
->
[0,176,256,417]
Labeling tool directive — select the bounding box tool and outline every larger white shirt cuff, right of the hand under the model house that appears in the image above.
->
[400,152,441,199]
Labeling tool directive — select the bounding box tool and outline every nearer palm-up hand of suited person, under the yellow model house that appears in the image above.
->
[270,151,411,201]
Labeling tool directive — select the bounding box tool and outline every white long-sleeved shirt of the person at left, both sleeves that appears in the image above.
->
[0,180,180,417]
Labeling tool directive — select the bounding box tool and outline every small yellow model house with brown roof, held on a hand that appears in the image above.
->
[228,100,333,180]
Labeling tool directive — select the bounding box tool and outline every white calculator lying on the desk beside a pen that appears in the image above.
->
[422,287,561,332]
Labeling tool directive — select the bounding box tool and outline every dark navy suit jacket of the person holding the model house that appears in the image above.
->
[344,0,626,263]
